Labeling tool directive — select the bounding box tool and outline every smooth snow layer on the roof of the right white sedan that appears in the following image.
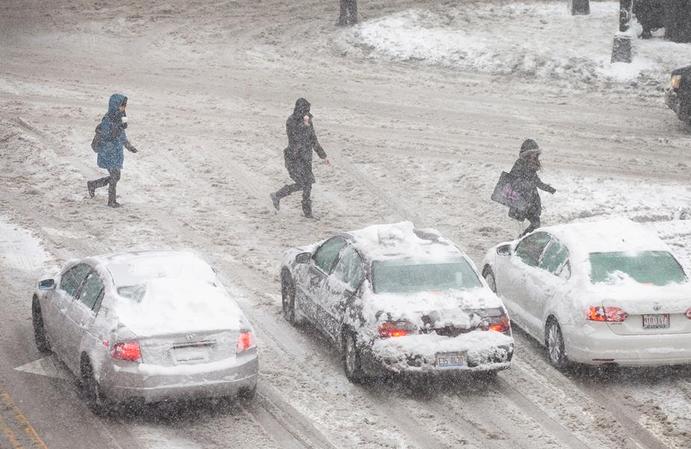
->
[542,218,669,257]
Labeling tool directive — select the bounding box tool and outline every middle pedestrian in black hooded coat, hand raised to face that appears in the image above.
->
[271,98,329,218]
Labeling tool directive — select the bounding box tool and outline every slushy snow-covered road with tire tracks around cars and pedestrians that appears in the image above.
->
[0,0,691,449]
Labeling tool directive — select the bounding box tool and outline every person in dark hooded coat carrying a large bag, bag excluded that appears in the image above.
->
[509,139,556,237]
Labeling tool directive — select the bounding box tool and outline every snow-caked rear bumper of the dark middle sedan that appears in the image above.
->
[368,331,514,374]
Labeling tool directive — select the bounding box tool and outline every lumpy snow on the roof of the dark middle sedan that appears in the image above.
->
[348,221,463,260]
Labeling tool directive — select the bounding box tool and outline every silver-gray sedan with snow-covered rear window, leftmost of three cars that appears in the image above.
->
[32,251,258,413]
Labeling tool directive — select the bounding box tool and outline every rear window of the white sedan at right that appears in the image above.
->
[590,251,687,285]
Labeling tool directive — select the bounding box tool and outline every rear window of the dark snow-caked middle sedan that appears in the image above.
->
[372,259,482,293]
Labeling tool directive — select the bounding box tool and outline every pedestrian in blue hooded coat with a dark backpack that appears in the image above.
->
[86,94,137,207]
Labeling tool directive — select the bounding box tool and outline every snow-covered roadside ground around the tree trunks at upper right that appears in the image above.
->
[342,2,691,90]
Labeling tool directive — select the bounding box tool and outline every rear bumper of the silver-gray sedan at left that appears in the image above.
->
[100,353,259,402]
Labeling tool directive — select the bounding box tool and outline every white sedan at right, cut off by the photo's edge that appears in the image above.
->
[482,219,691,368]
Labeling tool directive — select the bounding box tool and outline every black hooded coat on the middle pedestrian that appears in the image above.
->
[283,100,326,185]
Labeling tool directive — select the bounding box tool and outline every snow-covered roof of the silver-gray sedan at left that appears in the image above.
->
[93,251,216,286]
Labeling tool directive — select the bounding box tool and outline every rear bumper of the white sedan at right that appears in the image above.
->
[562,323,691,366]
